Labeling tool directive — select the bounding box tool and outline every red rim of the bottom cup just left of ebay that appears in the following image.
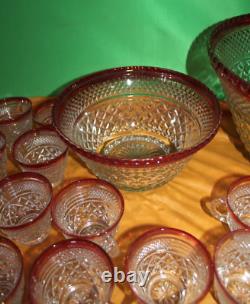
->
[28,239,114,304]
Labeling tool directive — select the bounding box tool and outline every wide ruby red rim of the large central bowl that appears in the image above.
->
[52,66,221,168]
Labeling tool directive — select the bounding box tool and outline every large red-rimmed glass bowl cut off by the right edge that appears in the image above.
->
[209,14,250,152]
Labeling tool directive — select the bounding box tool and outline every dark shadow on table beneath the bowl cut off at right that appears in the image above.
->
[221,102,250,161]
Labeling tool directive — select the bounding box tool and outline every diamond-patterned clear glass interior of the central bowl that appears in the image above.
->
[55,73,215,159]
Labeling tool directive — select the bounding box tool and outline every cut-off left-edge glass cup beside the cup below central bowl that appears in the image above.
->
[0,172,52,246]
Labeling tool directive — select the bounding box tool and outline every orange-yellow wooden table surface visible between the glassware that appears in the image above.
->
[8,98,249,304]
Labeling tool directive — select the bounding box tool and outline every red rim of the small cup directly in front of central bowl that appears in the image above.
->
[51,178,124,241]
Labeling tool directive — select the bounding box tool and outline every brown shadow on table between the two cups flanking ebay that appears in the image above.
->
[113,225,161,304]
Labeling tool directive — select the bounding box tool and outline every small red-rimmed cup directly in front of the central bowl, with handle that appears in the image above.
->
[52,179,124,257]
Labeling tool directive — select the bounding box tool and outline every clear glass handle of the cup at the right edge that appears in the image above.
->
[204,197,227,224]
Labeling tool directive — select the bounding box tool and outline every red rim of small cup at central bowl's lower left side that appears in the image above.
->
[12,126,68,168]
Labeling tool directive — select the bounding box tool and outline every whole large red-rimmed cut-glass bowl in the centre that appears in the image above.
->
[53,67,220,191]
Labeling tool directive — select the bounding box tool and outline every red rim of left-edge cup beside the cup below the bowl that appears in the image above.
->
[0,172,53,231]
